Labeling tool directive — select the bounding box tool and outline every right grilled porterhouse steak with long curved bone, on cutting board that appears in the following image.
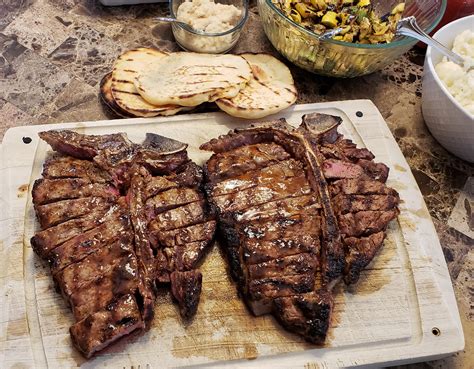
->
[201,114,399,343]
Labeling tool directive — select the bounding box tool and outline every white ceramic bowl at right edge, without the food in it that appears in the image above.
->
[422,15,474,163]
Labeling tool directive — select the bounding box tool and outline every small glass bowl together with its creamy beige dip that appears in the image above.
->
[170,0,248,54]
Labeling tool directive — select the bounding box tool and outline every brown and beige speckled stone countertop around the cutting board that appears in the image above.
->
[0,0,474,368]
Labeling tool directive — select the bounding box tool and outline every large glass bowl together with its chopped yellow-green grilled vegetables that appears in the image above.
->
[257,0,447,77]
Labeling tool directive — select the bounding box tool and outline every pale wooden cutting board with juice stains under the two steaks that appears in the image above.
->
[0,100,464,369]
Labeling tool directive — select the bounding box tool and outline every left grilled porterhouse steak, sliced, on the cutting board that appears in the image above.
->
[31,131,216,357]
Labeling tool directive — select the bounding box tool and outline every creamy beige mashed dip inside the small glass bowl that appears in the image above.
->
[175,0,242,53]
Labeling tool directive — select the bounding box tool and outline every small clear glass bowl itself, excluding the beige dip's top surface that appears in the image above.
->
[169,0,248,54]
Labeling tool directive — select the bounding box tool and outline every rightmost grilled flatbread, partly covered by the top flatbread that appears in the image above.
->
[216,54,297,119]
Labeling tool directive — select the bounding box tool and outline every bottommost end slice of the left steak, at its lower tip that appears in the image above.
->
[70,294,145,358]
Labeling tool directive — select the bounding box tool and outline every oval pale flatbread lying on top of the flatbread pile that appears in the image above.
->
[136,52,252,106]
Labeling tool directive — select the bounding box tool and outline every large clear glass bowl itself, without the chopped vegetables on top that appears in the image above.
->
[257,0,447,77]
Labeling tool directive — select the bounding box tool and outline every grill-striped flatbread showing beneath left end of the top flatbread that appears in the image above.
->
[111,48,188,117]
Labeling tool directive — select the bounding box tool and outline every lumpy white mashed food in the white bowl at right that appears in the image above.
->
[435,30,474,116]
